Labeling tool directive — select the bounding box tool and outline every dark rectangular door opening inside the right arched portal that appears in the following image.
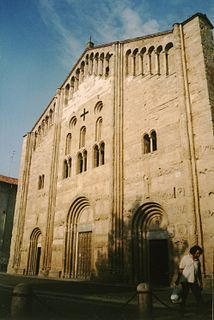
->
[149,239,169,286]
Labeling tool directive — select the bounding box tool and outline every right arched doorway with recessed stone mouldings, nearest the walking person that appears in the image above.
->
[132,202,169,286]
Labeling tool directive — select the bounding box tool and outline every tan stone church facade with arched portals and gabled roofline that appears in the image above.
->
[8,13,214,285]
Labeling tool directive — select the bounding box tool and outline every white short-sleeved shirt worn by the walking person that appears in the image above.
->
[179,255,200,283]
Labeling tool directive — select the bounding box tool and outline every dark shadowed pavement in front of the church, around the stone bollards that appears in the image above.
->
[0,273,213,320]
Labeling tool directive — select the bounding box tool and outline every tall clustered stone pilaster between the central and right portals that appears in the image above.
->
[112,43,124,274]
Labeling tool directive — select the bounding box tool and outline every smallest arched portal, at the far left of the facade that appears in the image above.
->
[27,228,42,275]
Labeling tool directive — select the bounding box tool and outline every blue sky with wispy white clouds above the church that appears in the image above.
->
[0,0,214,177]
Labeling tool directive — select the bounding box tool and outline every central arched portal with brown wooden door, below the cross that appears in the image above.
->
[64,197,93,279]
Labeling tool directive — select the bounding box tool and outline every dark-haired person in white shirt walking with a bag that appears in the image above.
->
[175,245,204,311]
